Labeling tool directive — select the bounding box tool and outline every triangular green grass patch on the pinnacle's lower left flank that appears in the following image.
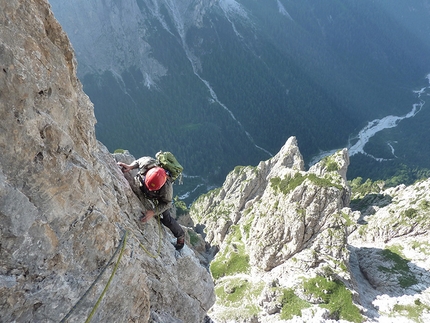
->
[210,226,250,279]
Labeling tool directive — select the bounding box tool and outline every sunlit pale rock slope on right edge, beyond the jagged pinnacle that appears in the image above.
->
[348,179,430,322]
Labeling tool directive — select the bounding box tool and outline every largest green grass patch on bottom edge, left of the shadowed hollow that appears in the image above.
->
[303,276,363,323]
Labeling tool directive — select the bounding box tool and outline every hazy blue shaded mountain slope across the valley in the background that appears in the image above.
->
[51,0,430,199]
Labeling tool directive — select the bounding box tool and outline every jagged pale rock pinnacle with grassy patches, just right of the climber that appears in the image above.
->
[191,137,353,322]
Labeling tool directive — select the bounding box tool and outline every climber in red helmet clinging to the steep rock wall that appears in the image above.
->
[117,157,185,250]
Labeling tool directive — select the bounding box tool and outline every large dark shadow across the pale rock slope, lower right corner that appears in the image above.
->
[348,246,430,318]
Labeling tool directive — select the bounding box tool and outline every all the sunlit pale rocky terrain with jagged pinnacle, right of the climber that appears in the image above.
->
[190,137,430,323]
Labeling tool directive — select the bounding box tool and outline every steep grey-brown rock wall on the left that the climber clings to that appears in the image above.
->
[0,0,215,322]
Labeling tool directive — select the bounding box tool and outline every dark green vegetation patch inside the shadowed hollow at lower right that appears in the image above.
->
[379,249,418,288]
